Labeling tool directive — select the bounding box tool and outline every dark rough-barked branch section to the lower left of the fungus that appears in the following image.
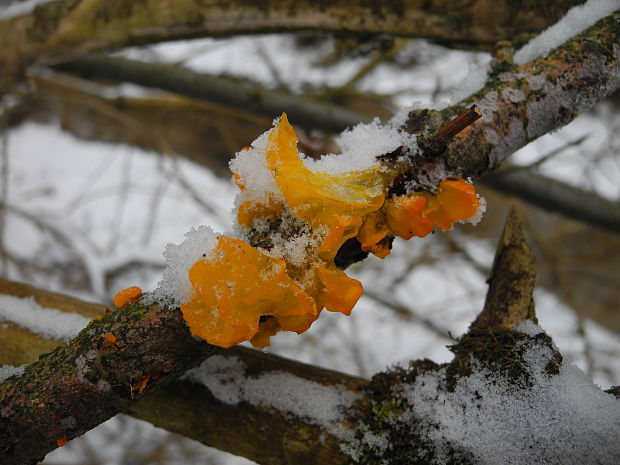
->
[0,280,216,465]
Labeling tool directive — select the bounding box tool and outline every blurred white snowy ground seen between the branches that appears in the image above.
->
[0,6,620,464]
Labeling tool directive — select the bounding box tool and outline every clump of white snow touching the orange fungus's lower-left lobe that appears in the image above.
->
[150,226,217,305]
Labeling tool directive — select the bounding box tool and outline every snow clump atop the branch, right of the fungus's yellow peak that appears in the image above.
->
[304,119,417,174]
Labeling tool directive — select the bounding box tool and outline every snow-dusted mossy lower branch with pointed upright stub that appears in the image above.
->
[0,212,620,465]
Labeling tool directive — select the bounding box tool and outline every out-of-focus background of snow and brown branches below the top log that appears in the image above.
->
[0,28,620,465]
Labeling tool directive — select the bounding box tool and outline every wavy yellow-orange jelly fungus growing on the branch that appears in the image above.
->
[179,114,480,348]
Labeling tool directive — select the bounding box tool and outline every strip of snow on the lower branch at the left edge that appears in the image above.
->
[0,295,90,341]
